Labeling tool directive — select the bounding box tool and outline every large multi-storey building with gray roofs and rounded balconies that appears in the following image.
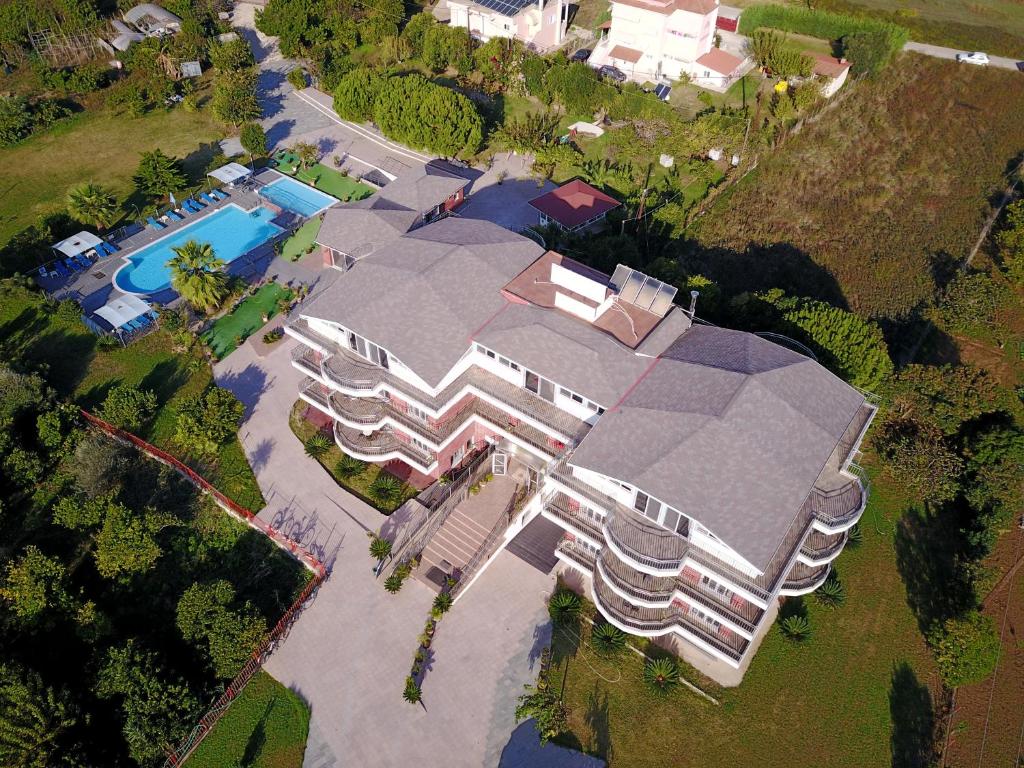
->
[286,217,874,685]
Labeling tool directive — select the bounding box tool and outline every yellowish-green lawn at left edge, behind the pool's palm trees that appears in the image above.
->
[0,108,223,243]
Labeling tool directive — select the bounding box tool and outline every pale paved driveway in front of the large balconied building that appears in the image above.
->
[214,341,598,768]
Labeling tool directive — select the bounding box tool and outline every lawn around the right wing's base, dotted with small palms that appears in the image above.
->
[552,460,935,768]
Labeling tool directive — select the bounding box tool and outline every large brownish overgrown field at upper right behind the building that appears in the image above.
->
[691,54,1024,323]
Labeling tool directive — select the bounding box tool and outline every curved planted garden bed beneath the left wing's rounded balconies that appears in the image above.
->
[288,399,419,515]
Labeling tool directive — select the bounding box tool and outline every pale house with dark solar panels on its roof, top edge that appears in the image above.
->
[447,0,569,51]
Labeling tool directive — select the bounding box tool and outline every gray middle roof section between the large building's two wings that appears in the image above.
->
[474,304,653,408]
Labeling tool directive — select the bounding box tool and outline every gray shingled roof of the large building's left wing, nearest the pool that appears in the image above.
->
[302,218,544,386]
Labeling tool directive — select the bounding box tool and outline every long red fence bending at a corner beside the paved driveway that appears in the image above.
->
[81,410,328,768]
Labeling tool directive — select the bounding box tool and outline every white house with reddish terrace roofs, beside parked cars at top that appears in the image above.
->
[590,0,745,90]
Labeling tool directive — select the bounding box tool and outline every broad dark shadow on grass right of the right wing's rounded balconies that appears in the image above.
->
[895,505,976,632]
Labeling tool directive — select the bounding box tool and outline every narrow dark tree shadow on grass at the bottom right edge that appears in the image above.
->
[889,662,936,768]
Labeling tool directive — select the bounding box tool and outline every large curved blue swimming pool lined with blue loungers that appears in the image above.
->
[114,205,282,294]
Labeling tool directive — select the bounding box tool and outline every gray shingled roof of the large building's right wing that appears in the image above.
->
[569,326,864,569]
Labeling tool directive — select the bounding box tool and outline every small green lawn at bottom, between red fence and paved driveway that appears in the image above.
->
[188,672,309,768]
